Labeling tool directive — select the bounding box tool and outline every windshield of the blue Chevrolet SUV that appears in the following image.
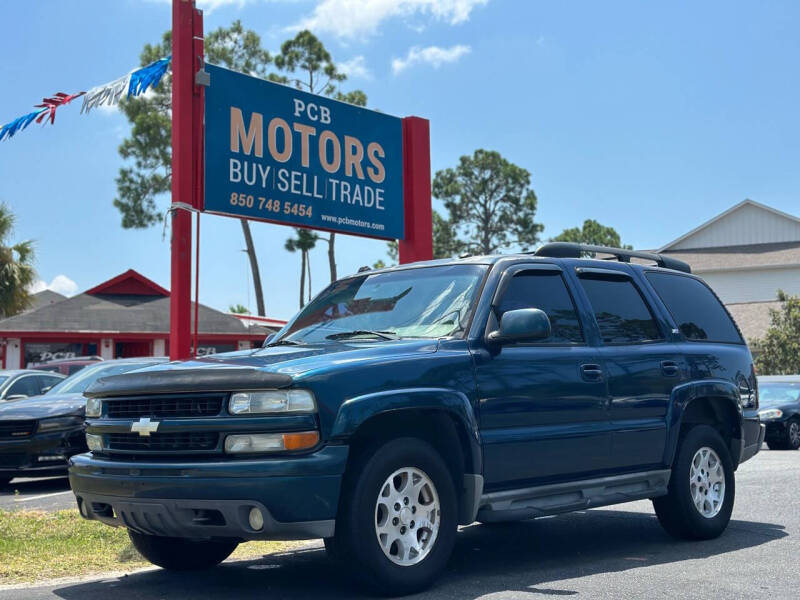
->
[282,265,487,344]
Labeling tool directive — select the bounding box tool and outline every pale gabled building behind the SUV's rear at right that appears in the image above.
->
[658,200,800,340]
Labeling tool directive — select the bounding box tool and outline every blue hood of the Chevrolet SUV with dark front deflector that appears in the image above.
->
[86,339,438,397]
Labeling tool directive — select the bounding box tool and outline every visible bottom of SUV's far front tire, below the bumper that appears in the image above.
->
[128,529,239,571]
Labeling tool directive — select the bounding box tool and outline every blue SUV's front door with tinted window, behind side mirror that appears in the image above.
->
[475,264,610,489]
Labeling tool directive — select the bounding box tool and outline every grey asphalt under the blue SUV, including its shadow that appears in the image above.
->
[0,450,800,600]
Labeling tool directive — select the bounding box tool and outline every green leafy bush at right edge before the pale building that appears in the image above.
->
[750,290,800,375]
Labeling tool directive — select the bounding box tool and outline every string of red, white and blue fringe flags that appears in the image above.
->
[0,56,172,141]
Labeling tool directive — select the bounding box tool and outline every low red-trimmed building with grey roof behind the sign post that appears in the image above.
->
[0,269,285,369]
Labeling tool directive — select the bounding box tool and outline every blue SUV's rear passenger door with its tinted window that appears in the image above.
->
[576,266,684,469]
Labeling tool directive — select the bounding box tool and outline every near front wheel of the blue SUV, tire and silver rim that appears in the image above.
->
[326,438,458,596]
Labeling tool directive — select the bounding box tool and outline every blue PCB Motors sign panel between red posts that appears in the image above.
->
[205,65,404,239]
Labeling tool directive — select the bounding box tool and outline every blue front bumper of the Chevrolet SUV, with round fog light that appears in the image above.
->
[69,446,348,540]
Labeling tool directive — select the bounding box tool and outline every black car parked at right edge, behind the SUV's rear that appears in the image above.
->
[758,375,800,450]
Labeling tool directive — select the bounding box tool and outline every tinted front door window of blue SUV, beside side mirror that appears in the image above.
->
[498,271,583,343]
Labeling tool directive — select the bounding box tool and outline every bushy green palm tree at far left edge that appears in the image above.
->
[0,204,36,317]
